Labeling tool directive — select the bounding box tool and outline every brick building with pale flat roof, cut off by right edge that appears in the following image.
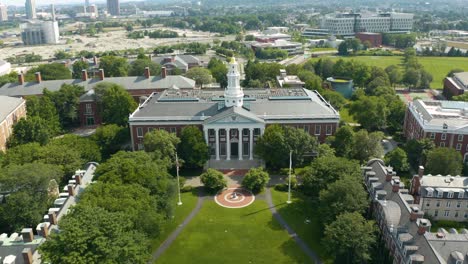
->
[403,100,468,161]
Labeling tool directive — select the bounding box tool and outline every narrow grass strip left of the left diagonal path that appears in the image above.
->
[151,191,198,251]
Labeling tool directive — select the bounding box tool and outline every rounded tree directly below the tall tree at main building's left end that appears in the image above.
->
[91,124,130,159]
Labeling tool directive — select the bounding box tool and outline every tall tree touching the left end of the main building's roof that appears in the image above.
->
[94,82,138,126]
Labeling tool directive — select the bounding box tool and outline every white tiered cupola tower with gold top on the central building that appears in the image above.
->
[224,57,244,107]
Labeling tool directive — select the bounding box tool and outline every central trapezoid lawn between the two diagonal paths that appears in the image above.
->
[157,200,310,264]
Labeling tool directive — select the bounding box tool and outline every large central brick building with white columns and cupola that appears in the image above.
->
[129,59,340,167]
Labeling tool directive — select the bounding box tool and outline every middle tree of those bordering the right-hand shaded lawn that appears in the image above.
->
[319,173,368,223]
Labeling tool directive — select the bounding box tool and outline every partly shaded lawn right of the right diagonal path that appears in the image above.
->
[271,189,333,263]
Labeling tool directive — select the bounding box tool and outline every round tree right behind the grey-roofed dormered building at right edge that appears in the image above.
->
[425,148,463,175]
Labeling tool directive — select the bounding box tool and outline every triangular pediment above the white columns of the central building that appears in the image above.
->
[205,107,265,124]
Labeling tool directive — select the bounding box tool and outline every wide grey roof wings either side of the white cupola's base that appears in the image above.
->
[130,89,340,122]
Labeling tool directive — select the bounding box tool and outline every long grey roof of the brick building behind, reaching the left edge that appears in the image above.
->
[0,75,195,97]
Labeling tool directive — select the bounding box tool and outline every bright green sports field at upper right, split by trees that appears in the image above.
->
[313,56,468,89]
